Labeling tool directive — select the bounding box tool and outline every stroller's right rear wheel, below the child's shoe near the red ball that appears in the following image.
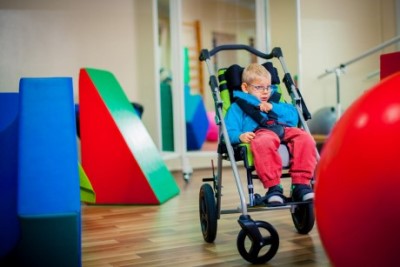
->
[292,203,315,235]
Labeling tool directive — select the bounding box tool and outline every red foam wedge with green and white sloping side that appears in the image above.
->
[79,68,179,204]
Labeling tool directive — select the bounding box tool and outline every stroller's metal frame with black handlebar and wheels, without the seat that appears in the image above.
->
[199,44,319,264]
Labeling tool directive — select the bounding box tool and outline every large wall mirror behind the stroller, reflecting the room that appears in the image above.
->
[158,0,297,155]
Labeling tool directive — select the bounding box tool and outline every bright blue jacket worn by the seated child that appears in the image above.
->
[225,91,299,144]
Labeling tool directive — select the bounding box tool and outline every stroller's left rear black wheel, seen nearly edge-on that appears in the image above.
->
[199,184,217,243]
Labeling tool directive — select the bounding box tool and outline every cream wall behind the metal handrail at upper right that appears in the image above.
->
[301,0,396,112]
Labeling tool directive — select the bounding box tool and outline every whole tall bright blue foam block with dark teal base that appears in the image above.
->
[16,77,81,266]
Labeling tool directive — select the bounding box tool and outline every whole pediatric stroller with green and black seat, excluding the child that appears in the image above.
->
[199,45,319,264]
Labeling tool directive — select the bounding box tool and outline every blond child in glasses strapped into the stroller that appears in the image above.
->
[225,63,317,204]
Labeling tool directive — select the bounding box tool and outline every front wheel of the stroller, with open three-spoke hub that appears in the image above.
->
[236,221,279,264]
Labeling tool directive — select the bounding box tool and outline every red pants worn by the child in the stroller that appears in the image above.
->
[250,127,317,188]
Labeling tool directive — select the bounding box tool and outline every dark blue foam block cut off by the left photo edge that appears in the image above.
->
[0,93,20,260]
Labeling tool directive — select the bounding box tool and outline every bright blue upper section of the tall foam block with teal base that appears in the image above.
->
[18,78,80,215]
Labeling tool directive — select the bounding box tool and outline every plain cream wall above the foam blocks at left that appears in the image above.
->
[0,0,162,142]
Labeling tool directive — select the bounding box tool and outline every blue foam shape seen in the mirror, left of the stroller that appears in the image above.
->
[185,86,209,151]
